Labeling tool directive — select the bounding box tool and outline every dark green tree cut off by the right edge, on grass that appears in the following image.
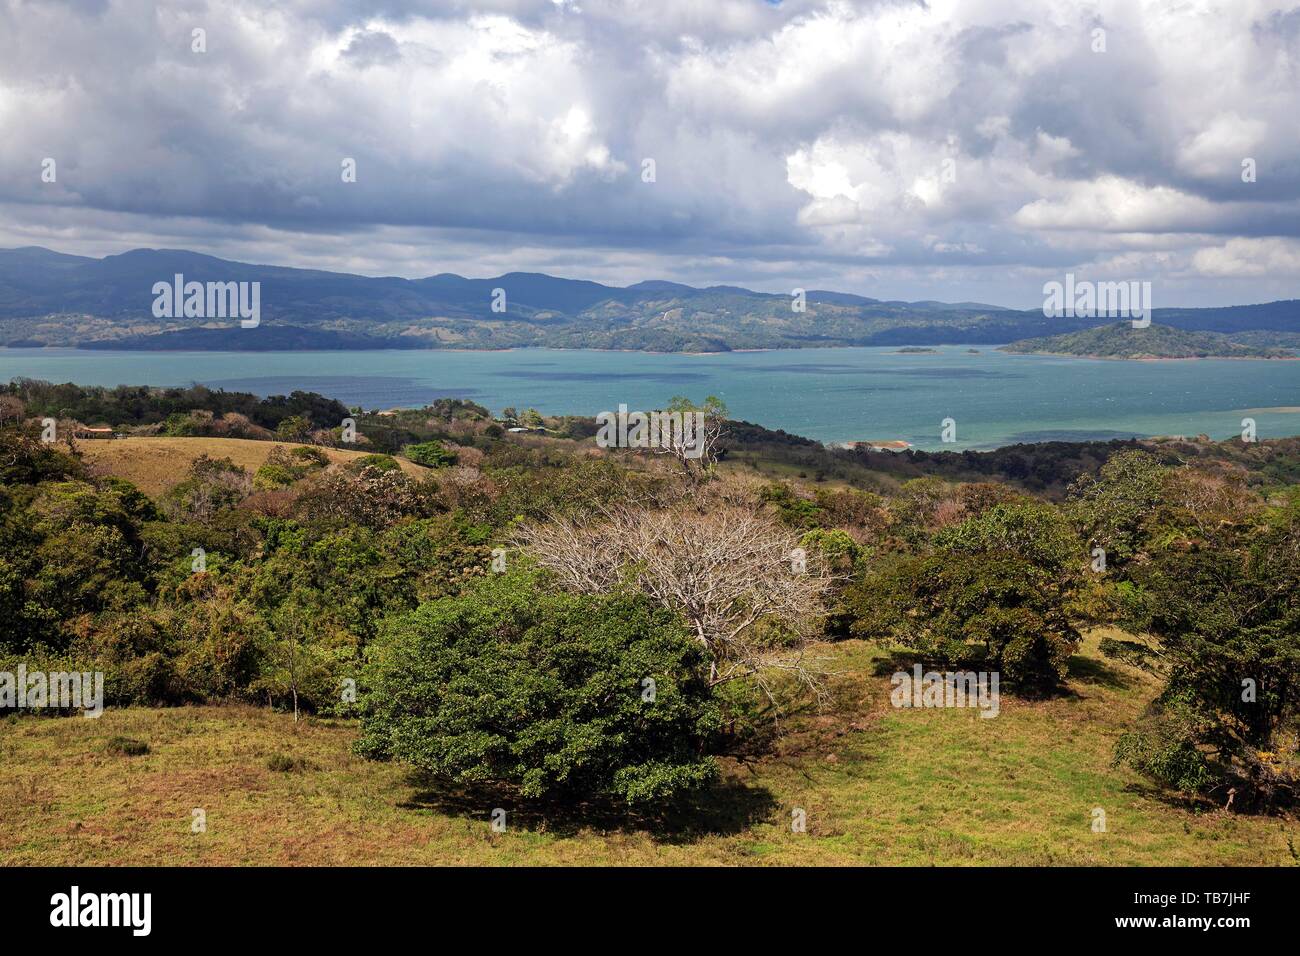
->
[1115,489,1300,809]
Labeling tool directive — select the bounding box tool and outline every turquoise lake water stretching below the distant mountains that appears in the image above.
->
[0,346,1300,450]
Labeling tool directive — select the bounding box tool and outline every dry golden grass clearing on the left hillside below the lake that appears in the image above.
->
[77,438,429,494]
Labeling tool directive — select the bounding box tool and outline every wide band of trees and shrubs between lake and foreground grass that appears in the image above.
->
[0,382,1300,842]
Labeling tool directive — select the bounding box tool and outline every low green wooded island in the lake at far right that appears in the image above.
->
[1000,321,1297,360]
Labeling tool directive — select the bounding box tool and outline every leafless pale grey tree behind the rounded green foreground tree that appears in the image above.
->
[515,496,832,696]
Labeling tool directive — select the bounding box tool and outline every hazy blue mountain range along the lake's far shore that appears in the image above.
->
[0,247,1300,351]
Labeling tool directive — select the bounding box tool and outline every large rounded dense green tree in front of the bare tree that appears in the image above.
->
[358,572,720,806]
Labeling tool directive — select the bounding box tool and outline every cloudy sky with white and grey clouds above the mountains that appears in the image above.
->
[0,0,1300,307]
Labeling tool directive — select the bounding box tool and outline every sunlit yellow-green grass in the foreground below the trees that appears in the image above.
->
[0,633,1300,866]
